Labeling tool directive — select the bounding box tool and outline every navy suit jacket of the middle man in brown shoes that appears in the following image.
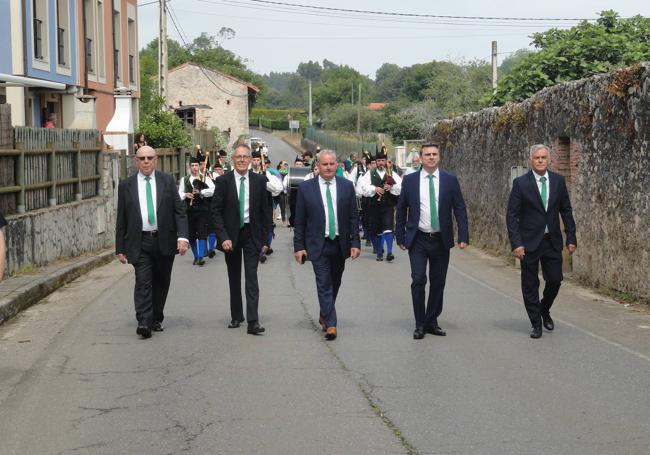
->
[293,177,361,260]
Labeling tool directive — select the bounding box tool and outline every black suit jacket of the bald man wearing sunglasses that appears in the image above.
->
[115,171,188,264]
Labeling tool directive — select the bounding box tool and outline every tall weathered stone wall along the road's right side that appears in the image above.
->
[428,64,650,300]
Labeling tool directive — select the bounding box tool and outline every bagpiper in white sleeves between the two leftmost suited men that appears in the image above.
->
[178,156,214,265]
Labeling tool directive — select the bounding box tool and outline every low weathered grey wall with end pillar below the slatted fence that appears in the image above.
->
[5,152,119,274]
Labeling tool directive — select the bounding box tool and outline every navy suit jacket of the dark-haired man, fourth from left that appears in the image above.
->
[396,169,469,248]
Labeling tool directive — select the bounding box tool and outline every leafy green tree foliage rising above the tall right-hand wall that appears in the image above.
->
[488,11,650,105]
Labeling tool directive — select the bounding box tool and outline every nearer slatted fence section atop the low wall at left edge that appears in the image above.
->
[0,127,102,214]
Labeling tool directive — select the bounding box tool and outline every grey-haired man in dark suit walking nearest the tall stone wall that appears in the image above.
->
[506,144,577,338]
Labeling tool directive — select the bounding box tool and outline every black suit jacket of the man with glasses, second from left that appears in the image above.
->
[211,171,273,251]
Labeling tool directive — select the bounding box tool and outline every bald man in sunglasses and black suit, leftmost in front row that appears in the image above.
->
[115,145,189,338]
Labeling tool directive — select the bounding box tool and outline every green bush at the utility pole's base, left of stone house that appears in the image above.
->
[137,97,192,148]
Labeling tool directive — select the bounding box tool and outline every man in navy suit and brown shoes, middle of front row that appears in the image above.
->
[293,150,361,340]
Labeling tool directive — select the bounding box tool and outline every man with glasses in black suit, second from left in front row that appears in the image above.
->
[212,144,273,335]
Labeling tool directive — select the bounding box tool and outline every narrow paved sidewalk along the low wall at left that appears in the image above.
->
[0,249,115,324]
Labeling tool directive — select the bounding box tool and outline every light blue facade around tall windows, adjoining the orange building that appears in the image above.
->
[24,0,79,85]
